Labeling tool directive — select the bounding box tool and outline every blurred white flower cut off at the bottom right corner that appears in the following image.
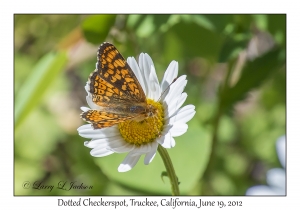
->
[246,136,286,195]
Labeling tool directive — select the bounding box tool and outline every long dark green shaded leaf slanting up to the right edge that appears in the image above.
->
[219,48,284,110]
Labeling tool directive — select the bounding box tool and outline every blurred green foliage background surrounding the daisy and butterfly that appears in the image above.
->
[14,14,286,195]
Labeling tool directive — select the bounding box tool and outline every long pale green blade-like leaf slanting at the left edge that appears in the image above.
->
[15,52,67,129]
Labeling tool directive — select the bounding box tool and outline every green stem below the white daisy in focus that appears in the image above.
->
[158,144,180,195]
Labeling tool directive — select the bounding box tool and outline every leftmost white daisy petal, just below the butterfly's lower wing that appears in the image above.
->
[77,124,121,139]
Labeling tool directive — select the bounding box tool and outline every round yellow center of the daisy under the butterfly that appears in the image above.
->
[118,99,164,146]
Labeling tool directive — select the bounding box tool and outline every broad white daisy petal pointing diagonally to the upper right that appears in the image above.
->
[160,75,187,104]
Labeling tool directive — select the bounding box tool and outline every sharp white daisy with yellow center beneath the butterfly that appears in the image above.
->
[78,53,195,172]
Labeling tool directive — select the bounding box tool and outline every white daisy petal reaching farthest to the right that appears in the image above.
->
[167,104,196,125]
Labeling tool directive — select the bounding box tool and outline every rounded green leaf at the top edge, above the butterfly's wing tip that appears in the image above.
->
[82,15,116,44]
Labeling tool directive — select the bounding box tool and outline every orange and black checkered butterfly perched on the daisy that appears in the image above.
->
[81,42,157,129]
